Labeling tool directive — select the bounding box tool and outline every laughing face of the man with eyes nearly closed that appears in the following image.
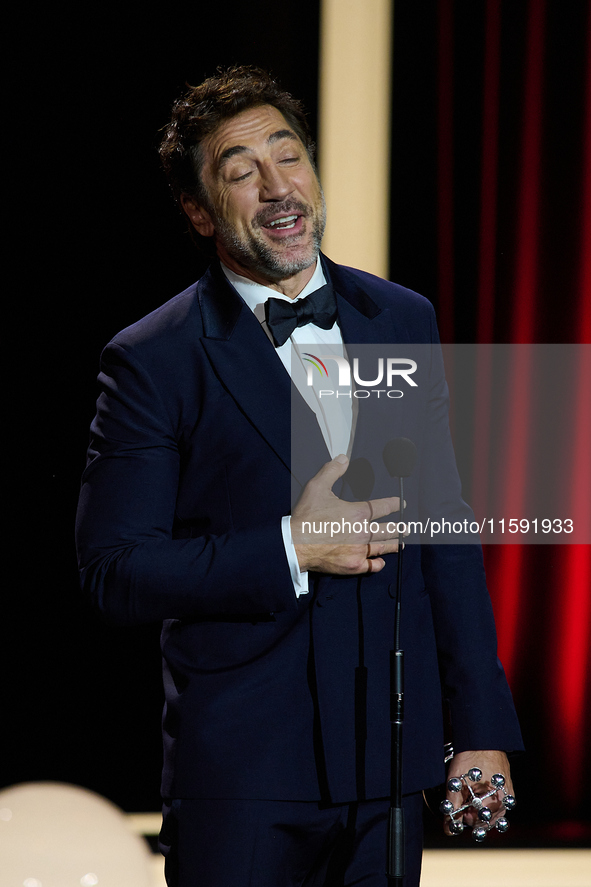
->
[185,105,325,292]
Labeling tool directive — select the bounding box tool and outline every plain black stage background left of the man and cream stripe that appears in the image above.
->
[1,0,318,811]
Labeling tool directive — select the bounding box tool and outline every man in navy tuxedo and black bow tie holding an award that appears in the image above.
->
[77,68,521,887]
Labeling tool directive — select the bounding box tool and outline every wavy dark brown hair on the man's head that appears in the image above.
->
[158,65,314,207]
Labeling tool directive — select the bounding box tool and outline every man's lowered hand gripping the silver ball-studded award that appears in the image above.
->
[444,751,514,835]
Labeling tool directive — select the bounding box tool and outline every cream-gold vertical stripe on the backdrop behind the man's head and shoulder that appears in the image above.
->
[318,0,394,277]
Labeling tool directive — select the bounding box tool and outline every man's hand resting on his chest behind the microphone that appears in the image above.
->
[291,455,400,575]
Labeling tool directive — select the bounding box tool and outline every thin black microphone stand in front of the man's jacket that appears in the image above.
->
[386,477,405,887]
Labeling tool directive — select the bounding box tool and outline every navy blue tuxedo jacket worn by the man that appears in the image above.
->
[77,258,521,802]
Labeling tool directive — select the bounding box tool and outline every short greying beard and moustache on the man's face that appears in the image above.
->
[210,190,326,281]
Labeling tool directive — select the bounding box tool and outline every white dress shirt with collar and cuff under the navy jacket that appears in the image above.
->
[222,260,353,597]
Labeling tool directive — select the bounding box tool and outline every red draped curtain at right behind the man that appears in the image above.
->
[436,0,591,816]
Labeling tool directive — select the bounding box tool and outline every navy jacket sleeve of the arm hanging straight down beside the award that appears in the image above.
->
[420,306,523,752]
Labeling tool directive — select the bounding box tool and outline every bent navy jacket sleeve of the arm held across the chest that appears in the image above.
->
[76,343,296,624]
